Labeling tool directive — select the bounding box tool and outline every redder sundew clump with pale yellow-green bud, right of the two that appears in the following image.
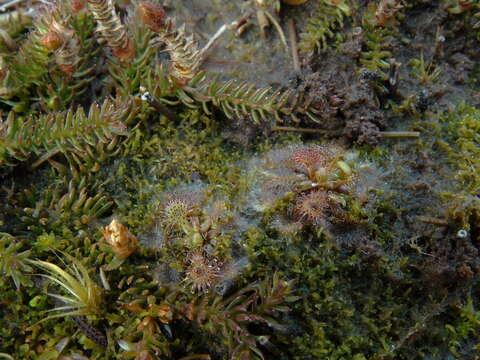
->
[252,144,354,233]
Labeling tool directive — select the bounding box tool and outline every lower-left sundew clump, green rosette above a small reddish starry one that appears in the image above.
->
[158,190,235,294]
